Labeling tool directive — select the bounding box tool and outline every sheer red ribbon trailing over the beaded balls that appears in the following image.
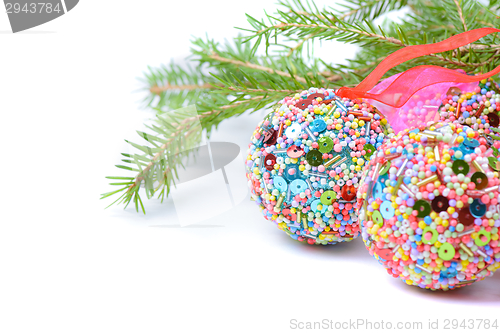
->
[336,28,500,108]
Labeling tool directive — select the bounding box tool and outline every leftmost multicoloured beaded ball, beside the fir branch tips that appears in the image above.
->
[246,88,393,245]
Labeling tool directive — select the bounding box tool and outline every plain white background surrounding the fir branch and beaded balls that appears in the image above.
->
[0,0,500,333]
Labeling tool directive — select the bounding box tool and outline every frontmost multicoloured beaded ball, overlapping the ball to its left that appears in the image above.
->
[357,122,500,290]
